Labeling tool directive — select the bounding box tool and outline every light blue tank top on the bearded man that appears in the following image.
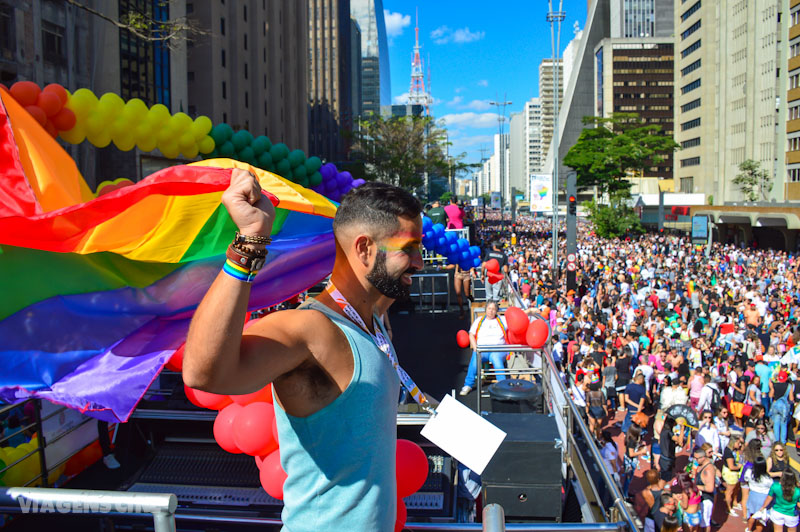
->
[275,300,400,532]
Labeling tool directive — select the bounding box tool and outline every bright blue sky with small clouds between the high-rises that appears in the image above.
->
[383,0,586,169]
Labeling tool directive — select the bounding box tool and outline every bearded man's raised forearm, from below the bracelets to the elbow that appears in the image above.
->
[183,272,250,392]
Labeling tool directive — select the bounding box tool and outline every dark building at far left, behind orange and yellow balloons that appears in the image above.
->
[0,0,188,188]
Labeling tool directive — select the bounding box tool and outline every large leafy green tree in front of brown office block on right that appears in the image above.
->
[564,113,680,200]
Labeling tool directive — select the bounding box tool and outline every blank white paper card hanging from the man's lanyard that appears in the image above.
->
[420,395,506,475]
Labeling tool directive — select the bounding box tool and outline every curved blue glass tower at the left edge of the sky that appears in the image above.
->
[350,0,392,117]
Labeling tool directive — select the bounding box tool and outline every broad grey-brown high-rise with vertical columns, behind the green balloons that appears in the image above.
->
[186,0,309,151]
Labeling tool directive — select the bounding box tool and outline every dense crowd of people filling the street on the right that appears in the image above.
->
[454,215,800,532]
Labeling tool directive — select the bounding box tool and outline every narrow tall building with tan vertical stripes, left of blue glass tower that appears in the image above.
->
[308,0,353,161]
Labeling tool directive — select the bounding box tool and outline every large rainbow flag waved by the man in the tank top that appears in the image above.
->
[0,89,337,421]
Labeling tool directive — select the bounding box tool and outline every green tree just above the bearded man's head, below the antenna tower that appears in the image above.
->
[351,117,450,191]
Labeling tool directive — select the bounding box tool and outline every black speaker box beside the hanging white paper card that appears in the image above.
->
[481,413,562,521]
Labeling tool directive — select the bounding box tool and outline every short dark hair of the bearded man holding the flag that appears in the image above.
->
[333,182,422,238]
